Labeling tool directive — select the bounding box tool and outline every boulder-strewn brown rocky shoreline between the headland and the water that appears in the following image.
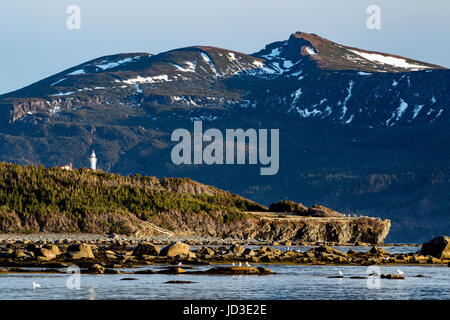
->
[0,234,450,275]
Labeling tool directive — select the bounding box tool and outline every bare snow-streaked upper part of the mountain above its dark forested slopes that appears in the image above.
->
[0,32,450,126]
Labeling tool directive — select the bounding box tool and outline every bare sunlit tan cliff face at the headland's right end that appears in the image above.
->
[147,212,391,244]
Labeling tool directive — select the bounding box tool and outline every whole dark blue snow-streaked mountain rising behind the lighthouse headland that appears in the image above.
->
[0,32,450,241]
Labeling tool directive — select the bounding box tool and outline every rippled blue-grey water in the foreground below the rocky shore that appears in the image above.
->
[0,265,450,300]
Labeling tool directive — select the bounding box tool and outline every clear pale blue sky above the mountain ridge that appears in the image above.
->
[0,0,450,94]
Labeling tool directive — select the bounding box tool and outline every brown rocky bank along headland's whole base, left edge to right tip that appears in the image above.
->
[0,210,391,244]
